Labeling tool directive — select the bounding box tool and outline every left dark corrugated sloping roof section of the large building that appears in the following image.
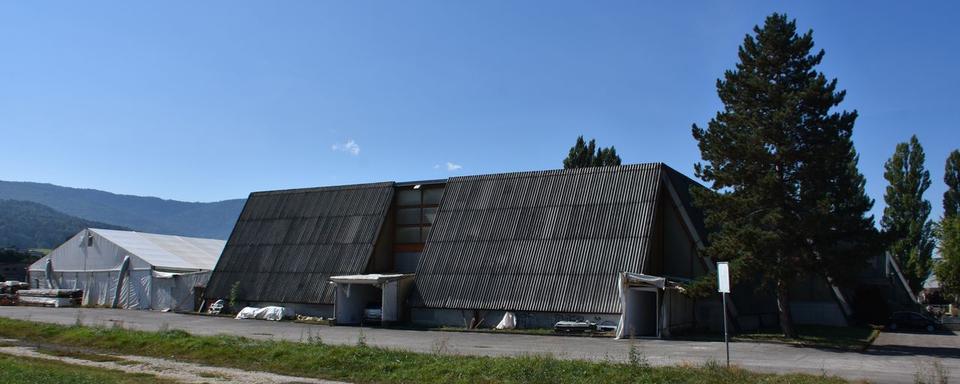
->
[206,182,394,304]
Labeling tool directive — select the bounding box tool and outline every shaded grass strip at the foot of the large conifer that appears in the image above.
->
[678,325,880,351]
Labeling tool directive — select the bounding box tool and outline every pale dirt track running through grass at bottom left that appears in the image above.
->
[0,339,346,384]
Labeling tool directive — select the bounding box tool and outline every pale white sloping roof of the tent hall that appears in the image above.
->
[90,228,225,270]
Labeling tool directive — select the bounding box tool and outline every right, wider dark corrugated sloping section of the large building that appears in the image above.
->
[411,164,668,313]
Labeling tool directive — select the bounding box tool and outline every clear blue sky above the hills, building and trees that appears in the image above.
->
[0,1,960,222]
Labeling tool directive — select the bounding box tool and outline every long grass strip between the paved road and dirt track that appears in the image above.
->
[0,319,843,384]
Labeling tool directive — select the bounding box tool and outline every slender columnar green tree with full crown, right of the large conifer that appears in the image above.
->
[881,135,934,291]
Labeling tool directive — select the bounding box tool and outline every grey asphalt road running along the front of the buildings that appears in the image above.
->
[0,307,960,383]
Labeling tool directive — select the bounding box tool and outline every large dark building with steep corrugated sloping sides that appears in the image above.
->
[206,163,908,337]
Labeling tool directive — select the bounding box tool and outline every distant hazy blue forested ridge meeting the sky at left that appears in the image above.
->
[0,181,245,239]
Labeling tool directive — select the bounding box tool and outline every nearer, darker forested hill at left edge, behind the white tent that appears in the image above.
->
[0,200,126,249]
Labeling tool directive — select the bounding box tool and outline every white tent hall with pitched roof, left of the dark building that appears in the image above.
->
[29,228,226,311]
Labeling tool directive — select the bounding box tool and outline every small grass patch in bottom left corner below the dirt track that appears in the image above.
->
[0,355,173,384]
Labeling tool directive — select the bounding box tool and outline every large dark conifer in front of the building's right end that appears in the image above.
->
[693,13,873,337]
